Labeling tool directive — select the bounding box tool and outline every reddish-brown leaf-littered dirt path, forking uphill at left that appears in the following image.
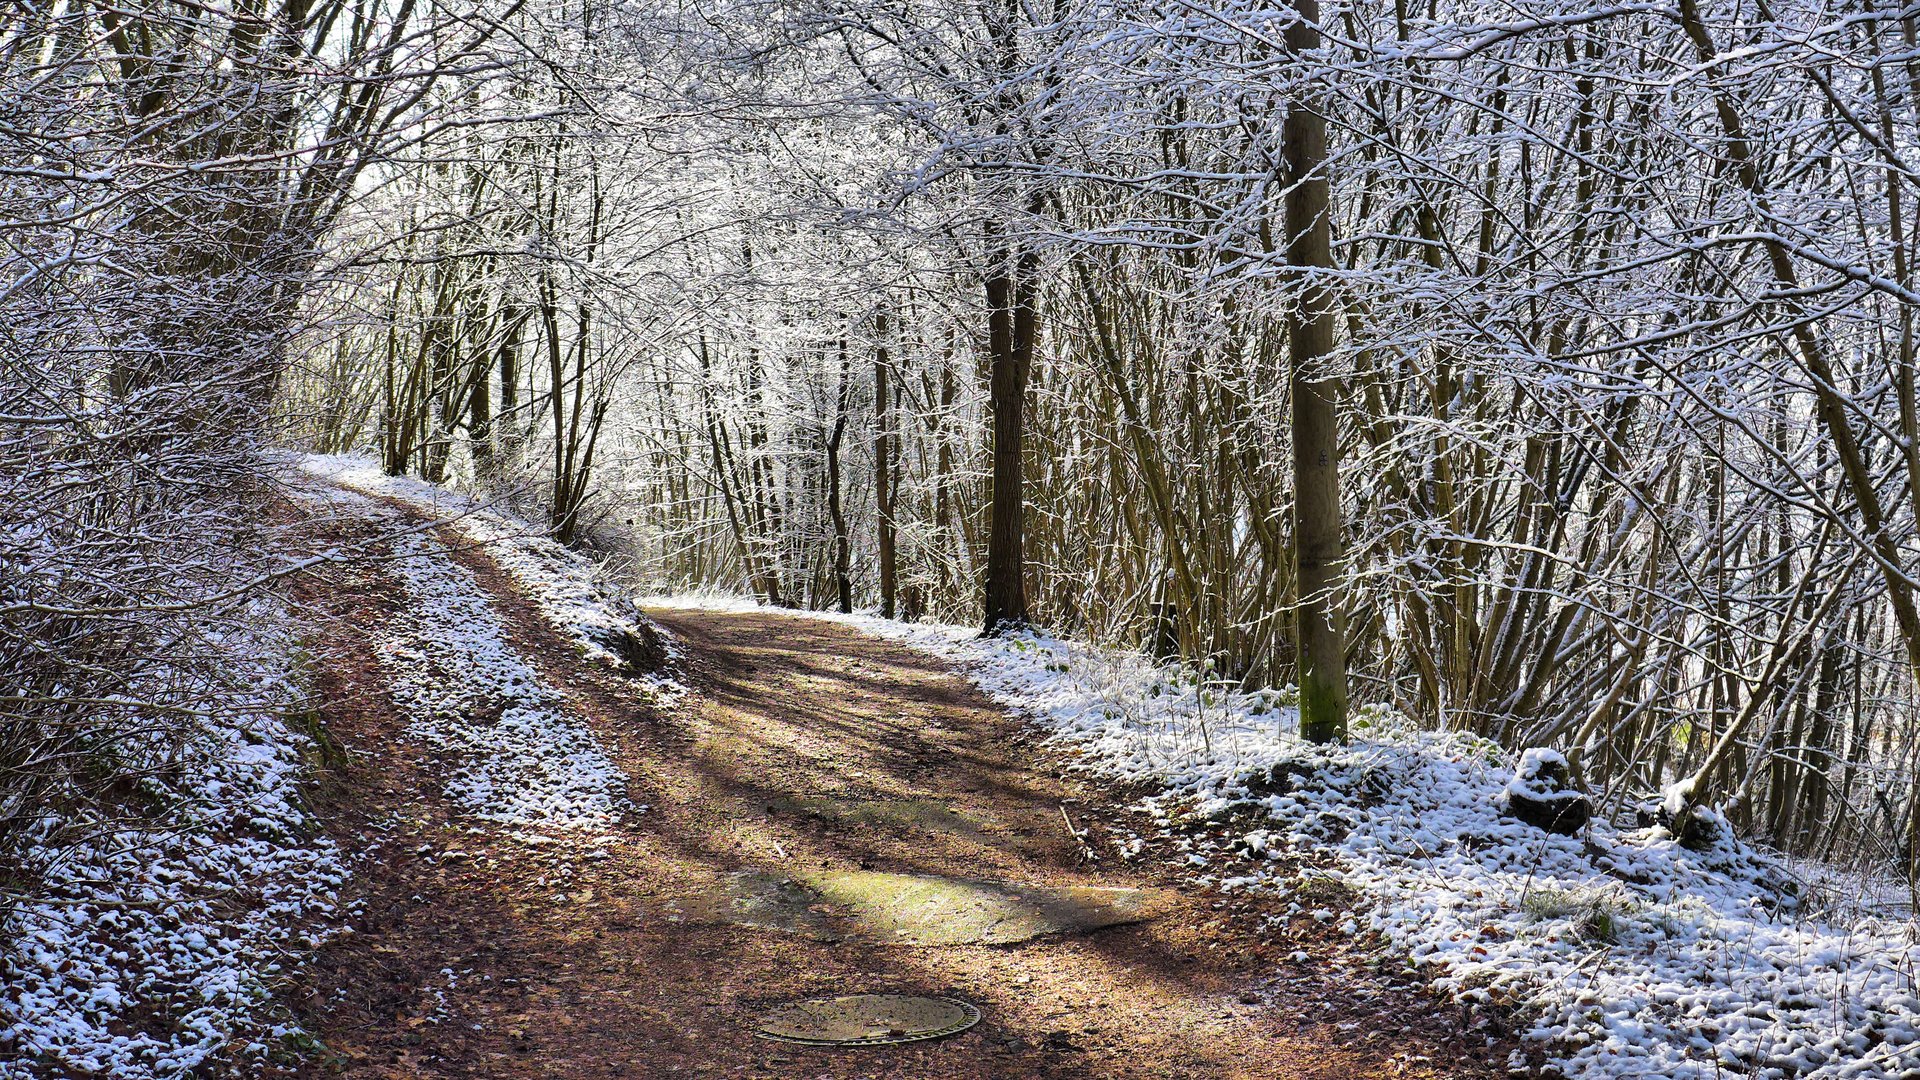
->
[278,518,1505,1080]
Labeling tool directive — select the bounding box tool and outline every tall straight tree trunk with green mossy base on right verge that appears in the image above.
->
[1281,0,1346,742]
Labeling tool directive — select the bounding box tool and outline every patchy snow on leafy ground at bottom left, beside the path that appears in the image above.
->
[0,601,346,1080]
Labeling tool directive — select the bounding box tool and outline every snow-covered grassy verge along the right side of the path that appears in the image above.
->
[647,596,1920,1080]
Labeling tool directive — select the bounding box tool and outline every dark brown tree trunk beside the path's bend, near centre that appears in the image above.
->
[985,231,1037,634]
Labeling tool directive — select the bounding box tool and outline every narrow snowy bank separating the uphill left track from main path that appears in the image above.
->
[298,454,680,684]
